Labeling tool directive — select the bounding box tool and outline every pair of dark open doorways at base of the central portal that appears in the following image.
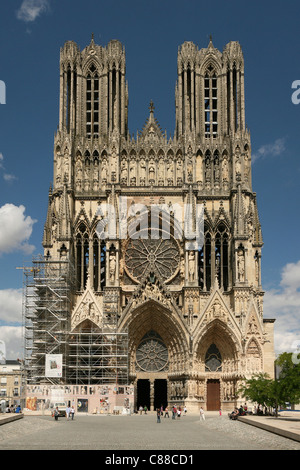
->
[136,379,168,411]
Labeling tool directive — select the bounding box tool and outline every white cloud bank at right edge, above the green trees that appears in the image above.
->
[264,261,300,353]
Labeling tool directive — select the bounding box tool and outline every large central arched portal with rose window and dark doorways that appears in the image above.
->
[122,300,188,409]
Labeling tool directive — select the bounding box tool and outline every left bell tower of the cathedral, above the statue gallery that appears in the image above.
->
[59,37,128,139]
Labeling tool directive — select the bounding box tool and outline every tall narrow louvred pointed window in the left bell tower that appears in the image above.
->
[86,63,100,138]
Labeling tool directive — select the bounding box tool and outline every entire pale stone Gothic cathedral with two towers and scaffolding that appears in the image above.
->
[24,38,274,410]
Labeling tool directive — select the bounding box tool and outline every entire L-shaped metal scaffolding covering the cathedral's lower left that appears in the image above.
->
[23,256,128,385]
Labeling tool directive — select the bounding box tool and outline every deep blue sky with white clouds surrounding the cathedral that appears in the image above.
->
[0,0,300,358]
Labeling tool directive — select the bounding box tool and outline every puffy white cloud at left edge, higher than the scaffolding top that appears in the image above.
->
[0,204,36,254]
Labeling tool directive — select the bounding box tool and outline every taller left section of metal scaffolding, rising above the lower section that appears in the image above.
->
[23,256,74,384]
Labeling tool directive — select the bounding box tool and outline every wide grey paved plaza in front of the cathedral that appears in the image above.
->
[0,412,300,454]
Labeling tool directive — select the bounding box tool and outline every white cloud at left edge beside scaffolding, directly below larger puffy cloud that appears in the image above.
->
[0,289,23,324]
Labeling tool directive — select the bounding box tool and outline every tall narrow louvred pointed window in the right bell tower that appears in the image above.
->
[204,65,218,138]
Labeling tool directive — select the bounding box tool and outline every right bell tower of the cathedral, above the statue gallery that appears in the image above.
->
[175,39,245,138]
